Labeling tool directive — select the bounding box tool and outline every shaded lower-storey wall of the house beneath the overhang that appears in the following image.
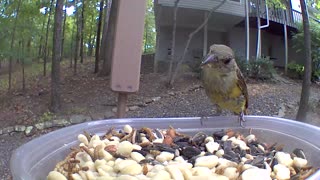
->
[156,27,303,67]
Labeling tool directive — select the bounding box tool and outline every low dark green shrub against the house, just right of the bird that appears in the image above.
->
[236,57,275,80]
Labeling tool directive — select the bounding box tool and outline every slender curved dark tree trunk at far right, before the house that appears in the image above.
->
[296,0,312,121]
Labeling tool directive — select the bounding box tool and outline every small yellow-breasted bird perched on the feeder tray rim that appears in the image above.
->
[201,44,248,126]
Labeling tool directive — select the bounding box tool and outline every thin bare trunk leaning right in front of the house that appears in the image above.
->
[169,0,227,86]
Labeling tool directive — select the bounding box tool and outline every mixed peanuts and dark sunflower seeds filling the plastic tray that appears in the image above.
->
[47,125,318,180]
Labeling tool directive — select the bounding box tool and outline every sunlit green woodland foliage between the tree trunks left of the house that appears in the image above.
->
[0,0,156,61]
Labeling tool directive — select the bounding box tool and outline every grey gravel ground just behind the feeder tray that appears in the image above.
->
[0,73,320,179]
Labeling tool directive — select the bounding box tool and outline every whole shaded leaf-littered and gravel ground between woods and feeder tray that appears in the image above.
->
[0,60,320,179]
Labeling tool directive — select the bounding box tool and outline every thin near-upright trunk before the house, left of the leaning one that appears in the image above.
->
[168,0,180,82]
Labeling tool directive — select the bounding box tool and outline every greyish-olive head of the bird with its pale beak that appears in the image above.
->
[200,44,237,73]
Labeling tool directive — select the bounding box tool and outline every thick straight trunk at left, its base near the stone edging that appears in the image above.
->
[50,0,63,112]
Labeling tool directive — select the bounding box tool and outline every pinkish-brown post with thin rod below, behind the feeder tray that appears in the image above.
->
[111,0,146,118]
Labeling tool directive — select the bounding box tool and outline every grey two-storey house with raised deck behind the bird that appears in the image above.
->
[155,0,318,67]
